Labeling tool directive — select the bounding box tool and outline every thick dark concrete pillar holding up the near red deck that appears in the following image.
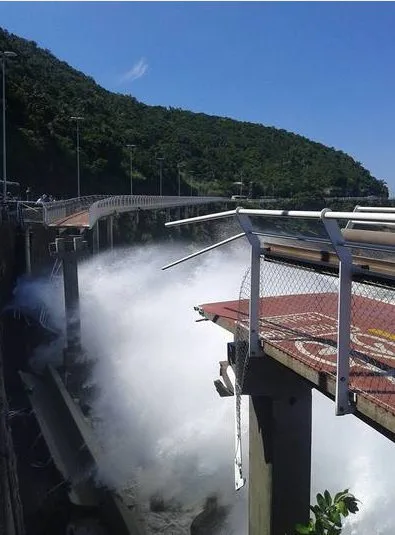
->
[244,356,312,535]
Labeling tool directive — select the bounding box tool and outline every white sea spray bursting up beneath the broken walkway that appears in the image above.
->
[10,243,395,535]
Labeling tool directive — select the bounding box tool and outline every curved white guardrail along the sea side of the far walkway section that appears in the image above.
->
[89,195,229,228]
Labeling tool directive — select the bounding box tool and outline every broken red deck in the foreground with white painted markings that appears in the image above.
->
[198,293,395,437]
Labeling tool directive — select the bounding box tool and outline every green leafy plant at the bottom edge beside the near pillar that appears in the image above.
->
[295,489,358,535]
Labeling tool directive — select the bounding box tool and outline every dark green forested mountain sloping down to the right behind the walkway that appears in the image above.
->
[0,29,388,196]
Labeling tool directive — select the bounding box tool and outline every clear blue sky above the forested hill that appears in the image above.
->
[0,2,395,194]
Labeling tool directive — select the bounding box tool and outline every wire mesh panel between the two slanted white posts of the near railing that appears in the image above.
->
[260,261,338,382]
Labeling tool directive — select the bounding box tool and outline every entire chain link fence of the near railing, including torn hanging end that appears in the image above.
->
[235,248,395,412]
